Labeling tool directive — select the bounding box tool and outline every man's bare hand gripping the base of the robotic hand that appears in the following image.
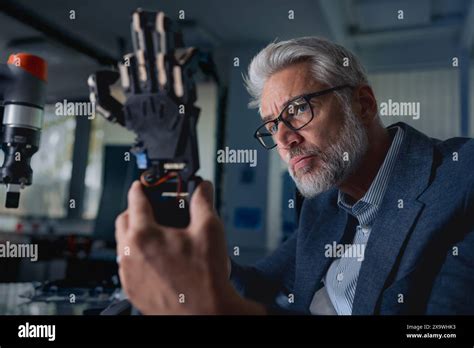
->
[115,181,265,314]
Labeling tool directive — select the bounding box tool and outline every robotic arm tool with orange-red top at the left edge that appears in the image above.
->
[0,53,47,208]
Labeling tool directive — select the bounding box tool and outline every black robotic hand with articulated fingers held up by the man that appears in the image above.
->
[88,9,201,227]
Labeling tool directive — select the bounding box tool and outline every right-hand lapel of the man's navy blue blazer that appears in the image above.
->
[352,123,433,315]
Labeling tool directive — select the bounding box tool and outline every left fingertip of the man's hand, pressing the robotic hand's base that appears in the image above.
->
[128,180,155,231]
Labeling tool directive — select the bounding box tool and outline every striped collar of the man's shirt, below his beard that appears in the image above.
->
[337,126,404,223]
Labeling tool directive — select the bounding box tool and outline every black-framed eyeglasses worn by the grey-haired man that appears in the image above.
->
[254,85,352,149]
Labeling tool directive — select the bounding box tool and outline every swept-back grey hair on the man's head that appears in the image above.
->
[244,36,368,108]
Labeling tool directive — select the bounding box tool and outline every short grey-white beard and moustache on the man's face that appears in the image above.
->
[287,105,368,198]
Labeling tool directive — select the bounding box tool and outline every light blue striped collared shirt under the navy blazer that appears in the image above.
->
[313,127,404,315]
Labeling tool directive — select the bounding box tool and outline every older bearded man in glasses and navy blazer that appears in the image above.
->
[112,37,474,315]
